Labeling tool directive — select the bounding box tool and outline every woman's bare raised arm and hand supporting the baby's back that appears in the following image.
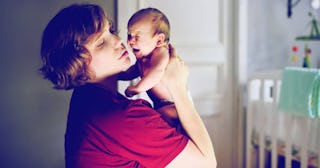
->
[163,46,217,168]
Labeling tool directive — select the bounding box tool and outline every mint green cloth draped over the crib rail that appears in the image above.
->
[278,67,320,118]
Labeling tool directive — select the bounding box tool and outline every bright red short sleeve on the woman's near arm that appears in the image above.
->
[101,100,188,167]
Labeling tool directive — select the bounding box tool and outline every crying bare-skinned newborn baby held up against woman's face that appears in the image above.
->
[122,8,177,123]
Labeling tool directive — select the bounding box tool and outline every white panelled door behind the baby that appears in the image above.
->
[118,0,238,168]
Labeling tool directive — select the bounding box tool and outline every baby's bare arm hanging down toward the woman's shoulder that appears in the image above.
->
[126,47,169,97]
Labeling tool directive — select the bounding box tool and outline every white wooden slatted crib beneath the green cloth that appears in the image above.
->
[245,70,320,168]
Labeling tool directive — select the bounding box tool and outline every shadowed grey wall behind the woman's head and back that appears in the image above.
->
[0,0,115,168]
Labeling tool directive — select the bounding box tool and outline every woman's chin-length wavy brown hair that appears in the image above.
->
[39,4,111,90]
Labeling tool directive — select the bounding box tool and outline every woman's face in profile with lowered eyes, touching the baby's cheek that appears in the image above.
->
[85,23,131,82]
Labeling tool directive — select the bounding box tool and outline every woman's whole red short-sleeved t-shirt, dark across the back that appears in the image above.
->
[65,85,188,168]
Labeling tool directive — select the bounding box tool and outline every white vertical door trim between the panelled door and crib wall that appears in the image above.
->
[233,0,248,167]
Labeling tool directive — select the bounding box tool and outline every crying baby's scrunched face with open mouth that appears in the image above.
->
[128,18,158,59]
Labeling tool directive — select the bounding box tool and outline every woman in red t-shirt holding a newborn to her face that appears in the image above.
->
[40,4,216,168]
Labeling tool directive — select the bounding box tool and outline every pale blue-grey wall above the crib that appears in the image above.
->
[247,0,320,76]
